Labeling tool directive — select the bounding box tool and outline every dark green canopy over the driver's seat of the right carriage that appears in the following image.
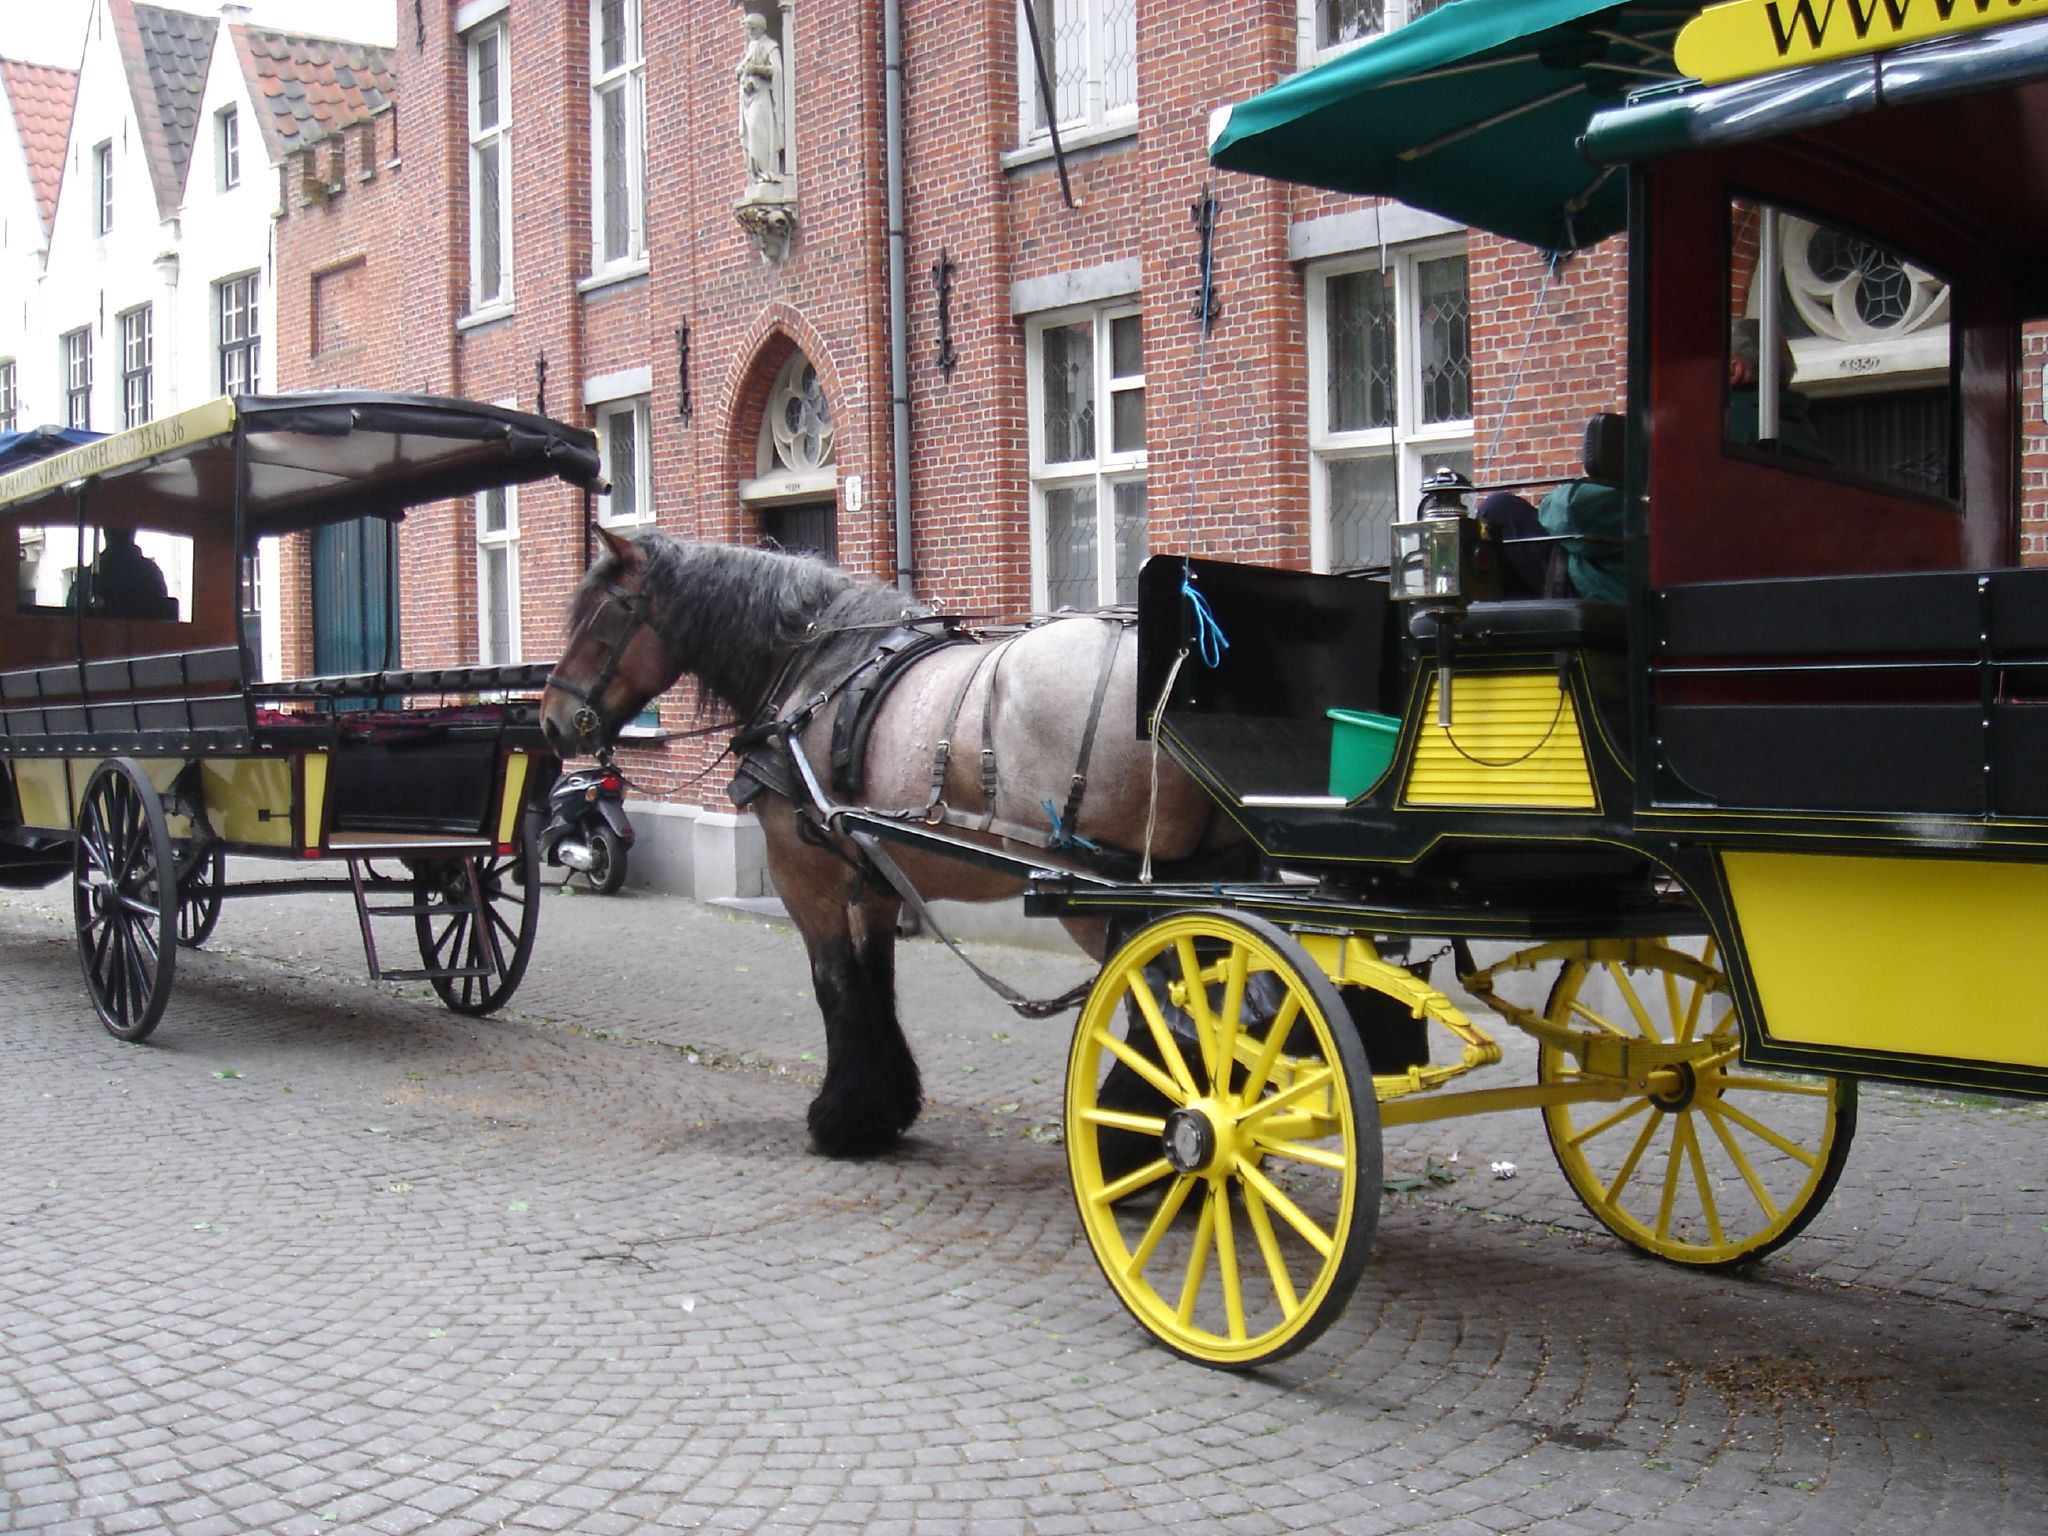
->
[1208,0,1700,250]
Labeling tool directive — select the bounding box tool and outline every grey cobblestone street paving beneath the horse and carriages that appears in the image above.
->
[0,870,2048,1536]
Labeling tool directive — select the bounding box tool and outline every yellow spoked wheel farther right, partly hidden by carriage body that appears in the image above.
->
[1536,942,1855,1270]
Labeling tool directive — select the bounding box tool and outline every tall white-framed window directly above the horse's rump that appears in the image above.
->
[1026,309,1145,610]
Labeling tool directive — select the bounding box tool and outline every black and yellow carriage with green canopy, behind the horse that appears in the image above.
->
[1028,0,2048,1366]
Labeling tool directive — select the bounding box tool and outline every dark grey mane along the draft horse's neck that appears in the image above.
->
[635,528,928,717]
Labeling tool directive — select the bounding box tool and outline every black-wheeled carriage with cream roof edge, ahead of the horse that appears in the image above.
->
[0,393,600,1040]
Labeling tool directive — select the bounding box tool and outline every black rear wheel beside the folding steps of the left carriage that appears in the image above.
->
[414,813,541,1016]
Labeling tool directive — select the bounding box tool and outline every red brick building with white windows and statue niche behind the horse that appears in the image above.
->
[279,0,2042,895]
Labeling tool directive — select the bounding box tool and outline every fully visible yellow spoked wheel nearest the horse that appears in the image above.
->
[1067,911,1380,1370]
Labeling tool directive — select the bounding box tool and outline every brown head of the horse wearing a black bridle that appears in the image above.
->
[541,528,676,758]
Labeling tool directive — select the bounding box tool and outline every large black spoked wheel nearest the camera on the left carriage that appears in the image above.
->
[72,758,178,1040]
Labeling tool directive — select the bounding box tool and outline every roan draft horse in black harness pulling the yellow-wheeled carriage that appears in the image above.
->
[541,528,1241,1157]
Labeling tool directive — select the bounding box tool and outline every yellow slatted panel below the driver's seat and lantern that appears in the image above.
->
[1403,672,1597,811]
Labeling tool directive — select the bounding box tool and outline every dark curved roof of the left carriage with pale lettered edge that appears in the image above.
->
[0,391,604,539]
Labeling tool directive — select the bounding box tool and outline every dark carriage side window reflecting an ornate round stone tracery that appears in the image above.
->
[1724,201,1956,498]
